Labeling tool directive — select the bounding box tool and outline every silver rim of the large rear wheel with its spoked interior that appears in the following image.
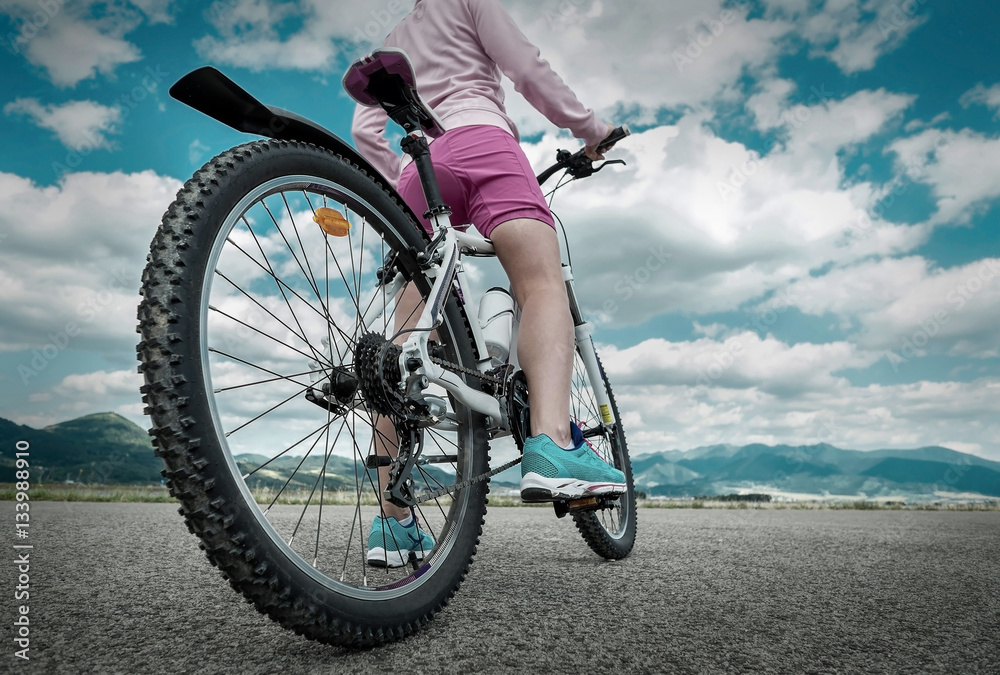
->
[199,176,473,599]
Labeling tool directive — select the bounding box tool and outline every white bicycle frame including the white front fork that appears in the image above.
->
[341,206,614,435]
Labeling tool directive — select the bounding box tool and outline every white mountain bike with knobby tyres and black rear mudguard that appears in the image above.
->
[137,50,636,646]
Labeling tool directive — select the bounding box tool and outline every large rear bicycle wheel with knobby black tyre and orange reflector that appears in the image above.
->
[137,141,489,646]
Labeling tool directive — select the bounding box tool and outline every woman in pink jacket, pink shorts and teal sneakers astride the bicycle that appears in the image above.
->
[353,0,625,566]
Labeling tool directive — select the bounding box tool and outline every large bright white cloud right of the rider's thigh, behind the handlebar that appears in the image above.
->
[526,98,928,325]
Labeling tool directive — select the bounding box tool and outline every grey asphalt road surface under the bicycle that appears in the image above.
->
[0,502,1000,674]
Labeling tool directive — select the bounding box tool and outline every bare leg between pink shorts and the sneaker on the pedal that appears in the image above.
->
[490,218,574,447]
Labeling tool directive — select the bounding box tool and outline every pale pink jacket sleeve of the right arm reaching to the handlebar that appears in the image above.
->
[466,0,608,145]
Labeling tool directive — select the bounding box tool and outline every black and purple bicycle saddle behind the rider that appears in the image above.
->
[343,48,444,138]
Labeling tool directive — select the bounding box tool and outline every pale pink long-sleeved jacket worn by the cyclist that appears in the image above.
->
[352,0,608,185]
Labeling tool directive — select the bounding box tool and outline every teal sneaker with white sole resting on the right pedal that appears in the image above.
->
[521,429,628,502]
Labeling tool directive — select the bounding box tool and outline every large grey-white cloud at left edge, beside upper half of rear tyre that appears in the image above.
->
[0,171,180,354]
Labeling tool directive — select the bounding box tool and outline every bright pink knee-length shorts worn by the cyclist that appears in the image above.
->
[399,125,555,237]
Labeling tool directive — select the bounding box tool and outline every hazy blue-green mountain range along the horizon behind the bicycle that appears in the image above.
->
[0,413,1000,500]
